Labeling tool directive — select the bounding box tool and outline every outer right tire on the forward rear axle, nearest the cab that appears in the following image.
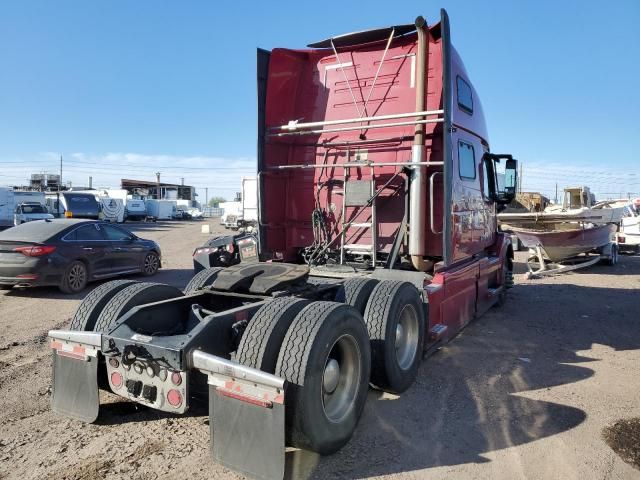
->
[364,280,425,393]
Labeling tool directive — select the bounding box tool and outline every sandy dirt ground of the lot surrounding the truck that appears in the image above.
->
[0,223,640,480]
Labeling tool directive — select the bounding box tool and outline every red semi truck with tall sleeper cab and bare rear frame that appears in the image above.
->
[49,10,517,479]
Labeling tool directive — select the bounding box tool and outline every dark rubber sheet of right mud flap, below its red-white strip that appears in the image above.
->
[209,385,285,480]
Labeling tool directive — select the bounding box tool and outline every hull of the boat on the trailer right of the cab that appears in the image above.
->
[514,224,616,262]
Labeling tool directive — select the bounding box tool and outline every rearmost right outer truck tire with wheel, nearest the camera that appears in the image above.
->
[276,302,371,455]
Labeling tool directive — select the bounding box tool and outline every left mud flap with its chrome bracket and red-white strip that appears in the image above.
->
[49,331,101,423]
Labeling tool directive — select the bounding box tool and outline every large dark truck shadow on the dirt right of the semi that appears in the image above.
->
[288,284,640,479]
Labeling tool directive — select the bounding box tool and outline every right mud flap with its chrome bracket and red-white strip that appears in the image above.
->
[192,351,285,480]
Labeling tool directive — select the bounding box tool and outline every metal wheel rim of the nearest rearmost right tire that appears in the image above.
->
[321,335,362,423]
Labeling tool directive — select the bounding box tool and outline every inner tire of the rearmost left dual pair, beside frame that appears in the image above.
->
[94,282,183,332]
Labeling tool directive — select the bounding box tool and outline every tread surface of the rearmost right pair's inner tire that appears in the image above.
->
[236,297,309,373]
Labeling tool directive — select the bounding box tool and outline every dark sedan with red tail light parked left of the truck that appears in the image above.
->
[0,219,161,293]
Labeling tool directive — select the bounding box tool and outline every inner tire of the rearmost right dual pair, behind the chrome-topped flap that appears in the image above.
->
[236,297,309,373]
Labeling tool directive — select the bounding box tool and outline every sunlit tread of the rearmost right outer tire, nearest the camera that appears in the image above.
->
[276,302,343,386]
